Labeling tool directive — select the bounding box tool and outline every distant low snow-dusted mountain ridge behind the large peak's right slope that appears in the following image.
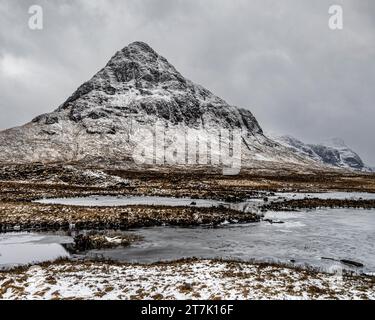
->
[272,136,371,171]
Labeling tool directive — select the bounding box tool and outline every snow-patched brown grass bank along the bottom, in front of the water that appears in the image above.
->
[0,260,375,299]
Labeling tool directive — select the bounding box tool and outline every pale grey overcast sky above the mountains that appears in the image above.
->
[0,0,375,166]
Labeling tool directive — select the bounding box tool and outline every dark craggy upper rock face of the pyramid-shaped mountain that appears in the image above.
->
[54,42,262,134]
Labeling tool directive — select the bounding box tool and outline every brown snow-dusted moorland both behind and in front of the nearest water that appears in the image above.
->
[0,164,375,299]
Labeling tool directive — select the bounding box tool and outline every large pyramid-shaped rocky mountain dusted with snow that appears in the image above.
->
[0,42,319,174]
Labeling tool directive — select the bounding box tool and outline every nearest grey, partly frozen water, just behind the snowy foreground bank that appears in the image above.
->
[0,209,375,273]
